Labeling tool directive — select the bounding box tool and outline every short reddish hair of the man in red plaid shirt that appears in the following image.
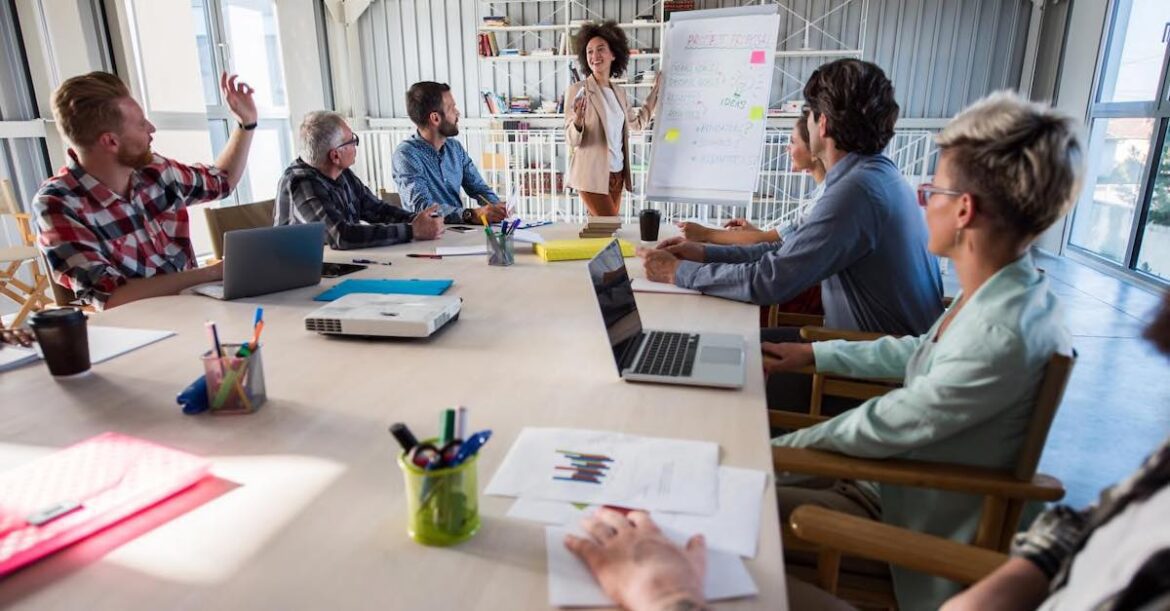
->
[53,71,130,147]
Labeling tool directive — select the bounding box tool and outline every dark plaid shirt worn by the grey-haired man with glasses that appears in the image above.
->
[274,158,414,250]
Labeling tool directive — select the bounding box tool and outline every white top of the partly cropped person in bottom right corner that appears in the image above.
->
[1040,487,1170,610]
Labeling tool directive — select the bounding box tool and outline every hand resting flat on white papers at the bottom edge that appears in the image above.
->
[565,508,707,611]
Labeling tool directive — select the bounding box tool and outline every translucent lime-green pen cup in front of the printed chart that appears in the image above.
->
[398,439,480,547]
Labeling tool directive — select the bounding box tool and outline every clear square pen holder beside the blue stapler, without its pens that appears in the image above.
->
[202,344,268,416]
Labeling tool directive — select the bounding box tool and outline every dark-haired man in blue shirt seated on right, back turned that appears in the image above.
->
[642,60,942,339]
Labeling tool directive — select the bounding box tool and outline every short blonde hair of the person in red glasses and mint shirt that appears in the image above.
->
[937,91,1083,238]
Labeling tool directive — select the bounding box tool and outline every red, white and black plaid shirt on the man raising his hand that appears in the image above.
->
[33,150,232,309]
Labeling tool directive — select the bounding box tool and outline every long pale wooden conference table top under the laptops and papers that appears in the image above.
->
[0,225,787,610]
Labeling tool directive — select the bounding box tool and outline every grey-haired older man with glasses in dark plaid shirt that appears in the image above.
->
[275,111,443,250]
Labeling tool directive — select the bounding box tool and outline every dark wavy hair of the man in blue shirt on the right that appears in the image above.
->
[804,60,899,155]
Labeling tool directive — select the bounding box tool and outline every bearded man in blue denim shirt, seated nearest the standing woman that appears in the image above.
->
[393,81,508,225]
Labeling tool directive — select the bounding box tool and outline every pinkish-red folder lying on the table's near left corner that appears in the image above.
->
[0,433,211,576]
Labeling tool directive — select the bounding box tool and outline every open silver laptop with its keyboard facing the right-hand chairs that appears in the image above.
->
[589,240,745,389]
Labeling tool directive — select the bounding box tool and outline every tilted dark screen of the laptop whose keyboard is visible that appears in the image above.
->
[589,240,642,373]
